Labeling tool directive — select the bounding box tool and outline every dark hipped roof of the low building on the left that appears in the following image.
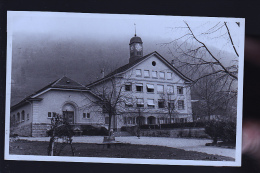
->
[11,76,94,110]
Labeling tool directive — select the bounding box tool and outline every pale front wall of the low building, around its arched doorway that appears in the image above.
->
[33,90,105,124]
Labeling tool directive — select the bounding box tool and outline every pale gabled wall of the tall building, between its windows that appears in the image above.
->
[92,56,193,128]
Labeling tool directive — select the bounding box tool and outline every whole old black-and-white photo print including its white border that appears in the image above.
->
[5,11,245,166]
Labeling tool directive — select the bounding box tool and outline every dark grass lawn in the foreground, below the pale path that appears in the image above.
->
[10,140,234,161]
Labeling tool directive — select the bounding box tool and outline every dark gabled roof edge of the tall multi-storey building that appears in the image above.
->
[87,51,193,87]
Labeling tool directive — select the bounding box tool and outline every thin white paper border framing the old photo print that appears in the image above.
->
[5,11,245,166]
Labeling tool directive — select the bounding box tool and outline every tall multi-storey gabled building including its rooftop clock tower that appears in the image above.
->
[88,36,193,129]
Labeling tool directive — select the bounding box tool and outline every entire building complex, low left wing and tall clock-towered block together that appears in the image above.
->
[11,35,193,136]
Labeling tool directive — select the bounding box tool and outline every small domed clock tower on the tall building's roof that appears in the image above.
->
[129,34,143,63]
